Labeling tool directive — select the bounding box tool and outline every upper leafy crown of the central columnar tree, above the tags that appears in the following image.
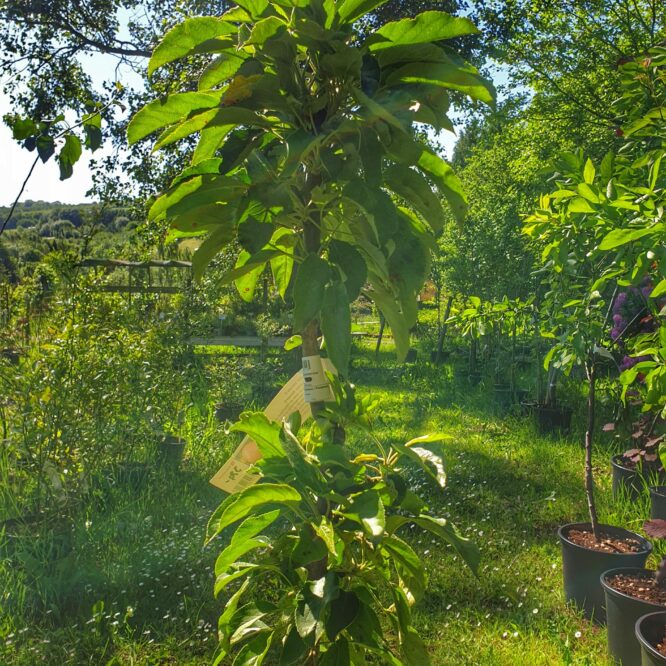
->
[128,1,494,374]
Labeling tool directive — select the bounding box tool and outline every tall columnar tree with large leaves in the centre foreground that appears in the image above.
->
[128,0,494,664]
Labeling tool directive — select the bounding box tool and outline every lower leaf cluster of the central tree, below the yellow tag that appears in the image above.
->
[208,383,479,666]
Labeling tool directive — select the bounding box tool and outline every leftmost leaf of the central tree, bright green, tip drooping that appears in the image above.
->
[127,91,223,144]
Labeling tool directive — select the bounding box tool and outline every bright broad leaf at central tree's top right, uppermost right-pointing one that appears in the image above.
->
[366,11,479,51]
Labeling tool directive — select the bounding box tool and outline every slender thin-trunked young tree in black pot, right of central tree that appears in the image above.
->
[526,148,651,621]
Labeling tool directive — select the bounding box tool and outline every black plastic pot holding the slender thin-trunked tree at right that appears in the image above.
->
[557,523,652,624]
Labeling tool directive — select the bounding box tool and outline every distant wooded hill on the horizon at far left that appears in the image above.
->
[0,200,131,236]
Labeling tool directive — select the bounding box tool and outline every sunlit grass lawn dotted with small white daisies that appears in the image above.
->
[0,345,654,666]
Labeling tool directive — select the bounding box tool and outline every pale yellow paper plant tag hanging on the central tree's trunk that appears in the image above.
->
[210,356,333,493]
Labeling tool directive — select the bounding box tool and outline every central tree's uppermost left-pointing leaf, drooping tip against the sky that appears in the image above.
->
[148,16,238,76]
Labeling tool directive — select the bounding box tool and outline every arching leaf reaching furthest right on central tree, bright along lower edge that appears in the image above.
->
[386,62,495,104]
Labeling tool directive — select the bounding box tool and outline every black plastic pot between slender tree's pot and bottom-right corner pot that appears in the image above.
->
[600,567,665,666]
